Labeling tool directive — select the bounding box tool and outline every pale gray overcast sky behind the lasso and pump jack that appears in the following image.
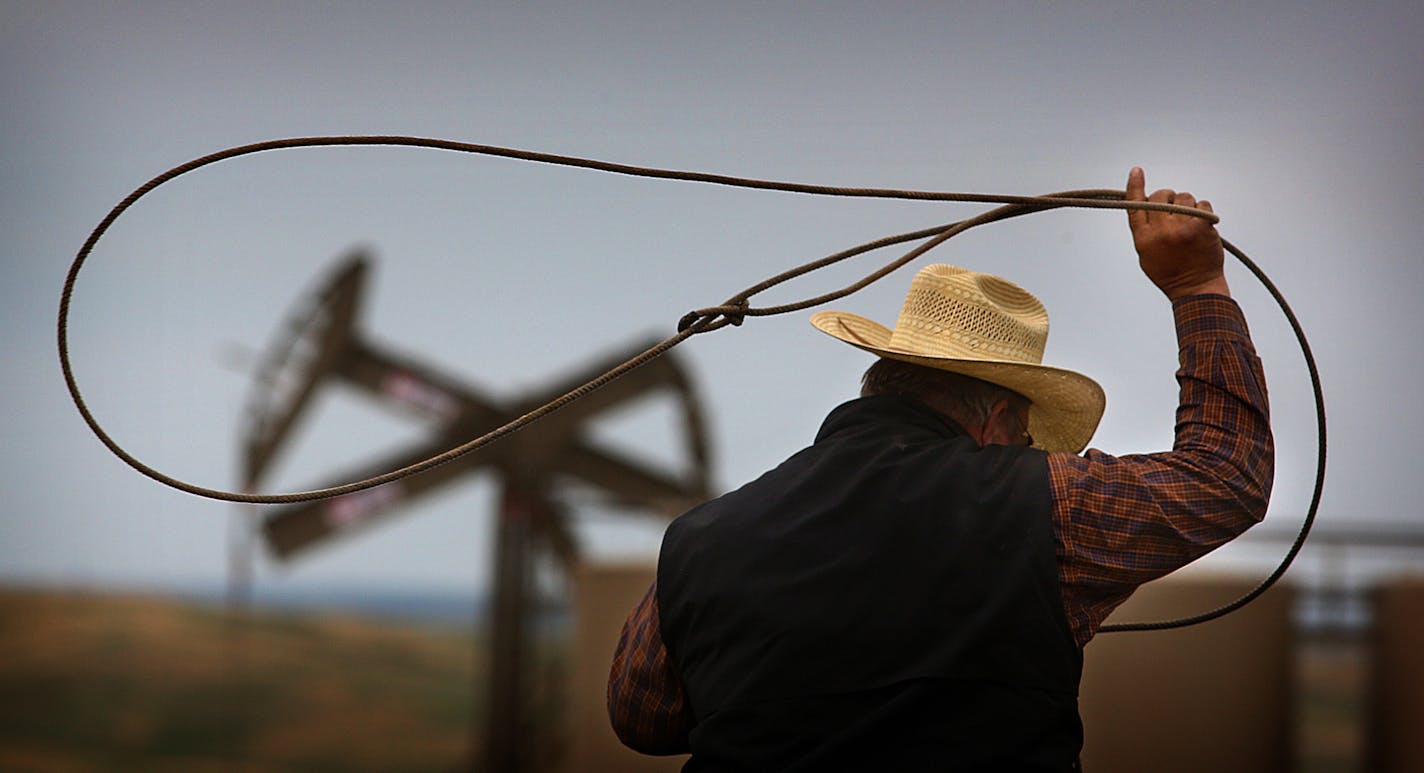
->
[0,1,1424,589]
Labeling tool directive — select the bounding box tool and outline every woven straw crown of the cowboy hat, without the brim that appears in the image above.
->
[889,265,1048,364]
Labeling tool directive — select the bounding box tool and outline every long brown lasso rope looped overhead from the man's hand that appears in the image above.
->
[58,135,1326,632]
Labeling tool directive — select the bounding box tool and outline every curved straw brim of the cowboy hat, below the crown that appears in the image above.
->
[810,312,1106,454]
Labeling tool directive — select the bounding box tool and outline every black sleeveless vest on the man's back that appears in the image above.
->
[658,396,1082,772]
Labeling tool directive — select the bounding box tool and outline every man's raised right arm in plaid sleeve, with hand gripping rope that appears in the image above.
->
[1048,169,1274,645]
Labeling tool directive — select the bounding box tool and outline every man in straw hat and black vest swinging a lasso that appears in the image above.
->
[608,168,1273,770]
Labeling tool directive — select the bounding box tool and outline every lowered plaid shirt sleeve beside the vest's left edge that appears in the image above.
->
[608,584,692,754]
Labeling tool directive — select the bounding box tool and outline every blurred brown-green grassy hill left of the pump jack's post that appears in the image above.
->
[0,589,501,772]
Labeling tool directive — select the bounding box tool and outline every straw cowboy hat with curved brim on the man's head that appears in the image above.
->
[810,265,1105,454]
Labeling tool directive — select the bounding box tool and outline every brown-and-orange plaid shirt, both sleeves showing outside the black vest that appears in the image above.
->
[608,295,1274,754]
